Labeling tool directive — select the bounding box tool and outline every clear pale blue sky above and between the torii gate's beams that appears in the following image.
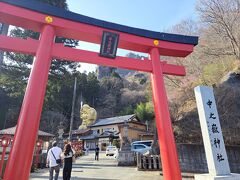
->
[67,0,197,71]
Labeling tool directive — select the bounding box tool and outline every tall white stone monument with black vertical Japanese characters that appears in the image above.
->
[194,86,240,180]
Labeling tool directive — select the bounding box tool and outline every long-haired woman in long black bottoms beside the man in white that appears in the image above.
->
[62,144,75,180]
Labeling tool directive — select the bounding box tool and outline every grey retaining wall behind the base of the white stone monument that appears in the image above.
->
[177,144,240,173]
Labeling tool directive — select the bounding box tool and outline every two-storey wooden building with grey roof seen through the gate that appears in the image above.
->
[80,114,153,150]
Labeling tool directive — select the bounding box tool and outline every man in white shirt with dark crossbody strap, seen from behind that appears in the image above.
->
[46,141,62,180]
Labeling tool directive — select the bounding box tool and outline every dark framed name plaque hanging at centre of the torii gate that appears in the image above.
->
[100,31,119,59]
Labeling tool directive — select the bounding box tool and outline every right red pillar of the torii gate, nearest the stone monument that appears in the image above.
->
[150,48,182,180]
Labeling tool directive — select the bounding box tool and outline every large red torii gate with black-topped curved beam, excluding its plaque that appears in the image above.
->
[0,0,198,180]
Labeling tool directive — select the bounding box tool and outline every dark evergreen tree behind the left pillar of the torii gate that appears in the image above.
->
[0,0,79,130]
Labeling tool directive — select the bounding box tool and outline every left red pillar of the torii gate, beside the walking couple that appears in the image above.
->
[4,25,55,180]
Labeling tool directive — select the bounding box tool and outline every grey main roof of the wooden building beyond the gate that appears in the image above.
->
[90,114,137,127]
